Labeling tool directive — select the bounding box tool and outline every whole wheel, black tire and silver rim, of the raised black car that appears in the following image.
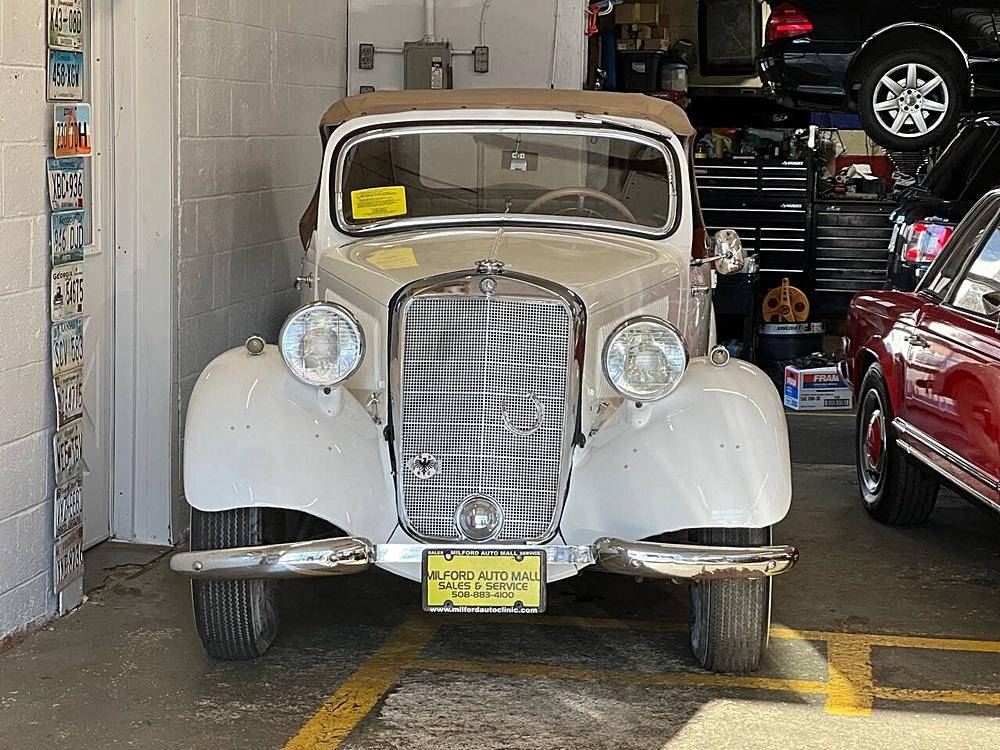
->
[858,49,966,151]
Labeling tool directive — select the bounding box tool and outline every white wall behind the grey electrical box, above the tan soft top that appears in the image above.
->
[347,0,587,94]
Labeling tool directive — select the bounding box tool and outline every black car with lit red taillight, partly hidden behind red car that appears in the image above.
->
[889,113,1000,292]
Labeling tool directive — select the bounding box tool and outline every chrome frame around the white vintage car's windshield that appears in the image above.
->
[332,123,682,239]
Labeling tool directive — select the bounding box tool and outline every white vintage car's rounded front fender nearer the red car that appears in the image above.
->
[560,357,792,544]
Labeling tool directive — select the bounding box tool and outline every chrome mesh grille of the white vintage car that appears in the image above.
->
[399,294,575,541]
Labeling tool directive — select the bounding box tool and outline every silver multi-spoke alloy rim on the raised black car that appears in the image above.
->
[872,63,951,138]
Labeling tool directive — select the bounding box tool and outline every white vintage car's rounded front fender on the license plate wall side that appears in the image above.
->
[184,346,396,542]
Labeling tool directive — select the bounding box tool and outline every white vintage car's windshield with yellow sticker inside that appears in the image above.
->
[331,125,677,234]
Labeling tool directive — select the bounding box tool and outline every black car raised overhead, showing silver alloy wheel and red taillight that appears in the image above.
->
[757,0,1000,151]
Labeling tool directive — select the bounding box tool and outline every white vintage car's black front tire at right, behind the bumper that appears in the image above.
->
[689,528,771,673]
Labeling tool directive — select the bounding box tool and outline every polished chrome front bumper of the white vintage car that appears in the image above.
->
[170,537,799,581]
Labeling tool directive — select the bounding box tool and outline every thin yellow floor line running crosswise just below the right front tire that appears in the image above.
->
[411,659,827,695]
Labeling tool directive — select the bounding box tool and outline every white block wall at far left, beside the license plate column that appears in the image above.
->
[0,0,56,640]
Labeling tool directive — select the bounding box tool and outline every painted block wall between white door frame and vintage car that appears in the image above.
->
[174,0,347,528]
